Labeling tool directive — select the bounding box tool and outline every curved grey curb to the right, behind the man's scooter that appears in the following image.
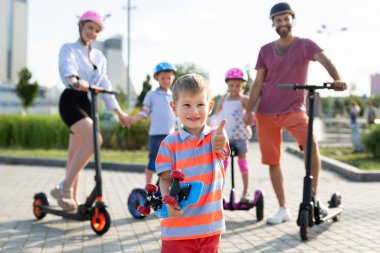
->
[286,146,380,182]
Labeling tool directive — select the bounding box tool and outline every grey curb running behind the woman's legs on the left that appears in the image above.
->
[0,156,146,173]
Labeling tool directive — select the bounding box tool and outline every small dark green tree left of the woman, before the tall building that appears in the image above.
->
[16,68,39,113]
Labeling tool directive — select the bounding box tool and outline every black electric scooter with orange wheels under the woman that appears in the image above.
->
[33,86,117,235]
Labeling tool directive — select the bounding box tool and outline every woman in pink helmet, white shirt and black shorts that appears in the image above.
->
[51,11,130,211]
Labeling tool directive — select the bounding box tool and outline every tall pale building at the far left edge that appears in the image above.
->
[0,0,28,83]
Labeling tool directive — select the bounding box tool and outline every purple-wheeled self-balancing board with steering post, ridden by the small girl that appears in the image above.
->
[223,145,264,221]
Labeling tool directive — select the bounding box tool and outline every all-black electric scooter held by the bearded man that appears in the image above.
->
[278,82,343,241]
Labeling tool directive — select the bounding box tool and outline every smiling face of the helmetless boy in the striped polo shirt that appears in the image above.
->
[171,92,214,137]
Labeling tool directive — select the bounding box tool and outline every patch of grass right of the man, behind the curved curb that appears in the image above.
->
[320,147,380,170]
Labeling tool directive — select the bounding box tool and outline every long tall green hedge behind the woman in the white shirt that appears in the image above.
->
[0,115,149,149]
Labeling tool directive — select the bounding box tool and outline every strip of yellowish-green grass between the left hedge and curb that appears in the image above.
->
[0,149,148,164]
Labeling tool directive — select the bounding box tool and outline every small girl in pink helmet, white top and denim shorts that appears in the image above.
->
[215,68,252,203]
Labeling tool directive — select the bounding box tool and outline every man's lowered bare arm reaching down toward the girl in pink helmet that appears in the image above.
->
[244,69,266,125]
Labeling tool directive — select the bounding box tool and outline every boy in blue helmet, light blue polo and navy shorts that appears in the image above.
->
[132,62,176,183]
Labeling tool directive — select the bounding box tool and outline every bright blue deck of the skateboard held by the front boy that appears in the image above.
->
[154,181,203,218]
